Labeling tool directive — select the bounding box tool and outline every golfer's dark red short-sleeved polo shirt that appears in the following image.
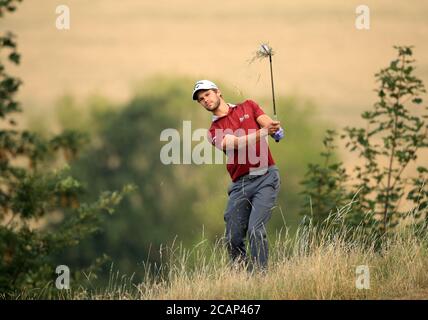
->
[208,100,275,182]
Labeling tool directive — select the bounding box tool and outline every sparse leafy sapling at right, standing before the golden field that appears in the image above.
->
[305,47,428,234]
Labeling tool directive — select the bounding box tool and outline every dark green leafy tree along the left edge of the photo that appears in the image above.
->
[0,0,131,294]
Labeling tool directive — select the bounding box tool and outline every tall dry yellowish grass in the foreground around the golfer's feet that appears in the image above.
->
[11,201,428,299]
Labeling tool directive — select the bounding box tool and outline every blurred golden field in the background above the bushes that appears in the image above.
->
[1,0,428,125]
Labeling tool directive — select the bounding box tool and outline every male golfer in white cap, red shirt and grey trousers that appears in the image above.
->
[193,80,284,270]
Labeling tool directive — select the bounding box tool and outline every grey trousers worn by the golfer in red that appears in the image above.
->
[224,166,281,269]
